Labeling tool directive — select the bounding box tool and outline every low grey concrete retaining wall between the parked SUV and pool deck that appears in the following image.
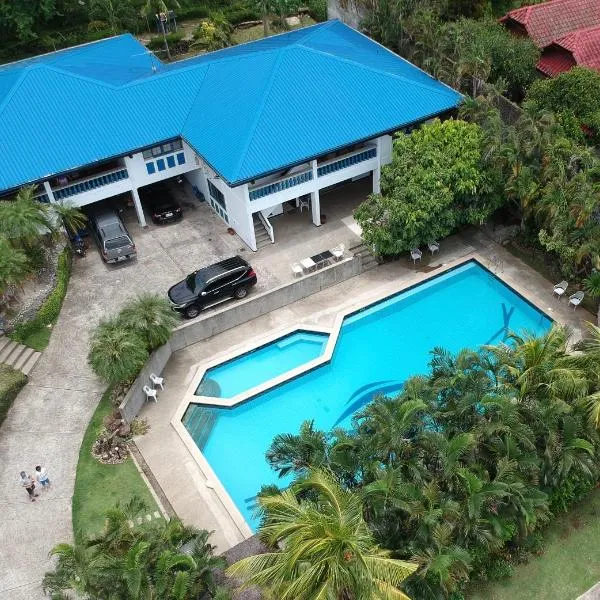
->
[119,256,363,422]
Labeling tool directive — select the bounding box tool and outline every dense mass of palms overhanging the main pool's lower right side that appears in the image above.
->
[240,325,600,600]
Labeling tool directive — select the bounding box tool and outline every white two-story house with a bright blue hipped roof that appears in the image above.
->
[0,21,461,250]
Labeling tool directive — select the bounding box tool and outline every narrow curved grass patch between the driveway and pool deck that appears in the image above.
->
[73,391,158,536]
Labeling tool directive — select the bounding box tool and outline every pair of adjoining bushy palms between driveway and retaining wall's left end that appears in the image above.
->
[88,294,179,384]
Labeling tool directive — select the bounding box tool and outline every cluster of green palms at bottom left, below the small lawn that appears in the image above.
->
[43,498,228,600]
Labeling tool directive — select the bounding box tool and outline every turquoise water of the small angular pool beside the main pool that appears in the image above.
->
[196,330,329,398]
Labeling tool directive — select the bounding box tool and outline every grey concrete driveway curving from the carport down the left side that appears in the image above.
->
[0,192,277,600]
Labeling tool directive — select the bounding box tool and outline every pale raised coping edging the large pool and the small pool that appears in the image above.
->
[171,256,555,538]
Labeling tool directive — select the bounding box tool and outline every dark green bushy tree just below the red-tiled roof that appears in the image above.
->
[526,67,600,137]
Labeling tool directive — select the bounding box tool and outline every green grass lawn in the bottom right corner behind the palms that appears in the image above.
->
[472,489,600,600]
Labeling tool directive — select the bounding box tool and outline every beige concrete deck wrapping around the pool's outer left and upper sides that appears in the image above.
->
[136,233,595,552]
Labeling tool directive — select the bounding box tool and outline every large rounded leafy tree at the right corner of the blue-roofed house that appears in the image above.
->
[354,120,498,255]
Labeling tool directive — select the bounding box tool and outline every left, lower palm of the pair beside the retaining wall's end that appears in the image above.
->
[88,319,148,383]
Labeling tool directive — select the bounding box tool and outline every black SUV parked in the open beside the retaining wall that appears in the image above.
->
[168,256,256,319]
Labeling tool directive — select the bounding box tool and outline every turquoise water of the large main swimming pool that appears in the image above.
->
[184,262,551,528]
